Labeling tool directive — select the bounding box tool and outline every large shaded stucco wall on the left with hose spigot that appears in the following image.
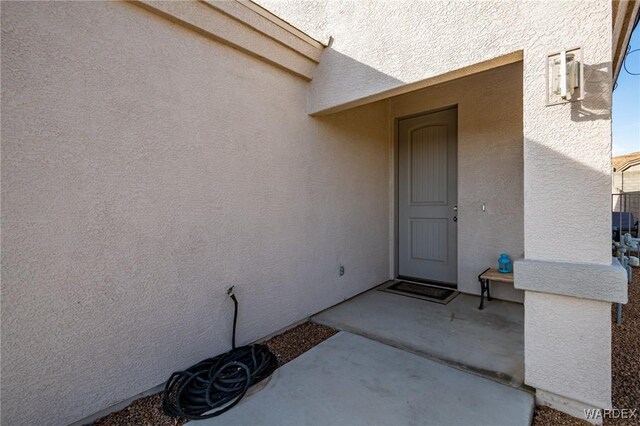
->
[1,2,390,425]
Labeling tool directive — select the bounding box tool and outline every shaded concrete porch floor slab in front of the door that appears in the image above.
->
[312,284,524,387]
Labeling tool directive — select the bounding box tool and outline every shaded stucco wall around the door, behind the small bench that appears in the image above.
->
[389,63,524,302]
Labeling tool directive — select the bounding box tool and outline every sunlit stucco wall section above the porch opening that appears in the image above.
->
[252,0,526,112]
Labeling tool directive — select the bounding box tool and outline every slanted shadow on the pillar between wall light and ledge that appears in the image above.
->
[524,136,611,264]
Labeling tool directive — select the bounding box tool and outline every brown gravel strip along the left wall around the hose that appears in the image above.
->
[93,322,338,426]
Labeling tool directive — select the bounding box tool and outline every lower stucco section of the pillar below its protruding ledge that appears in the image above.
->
[524,291,611,414]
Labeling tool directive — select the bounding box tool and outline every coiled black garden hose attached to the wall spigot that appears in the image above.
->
[162,287,278,420]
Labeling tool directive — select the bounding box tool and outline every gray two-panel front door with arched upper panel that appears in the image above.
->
[398,109,458,284]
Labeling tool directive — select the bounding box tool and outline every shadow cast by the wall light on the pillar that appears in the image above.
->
[571,62,611,121]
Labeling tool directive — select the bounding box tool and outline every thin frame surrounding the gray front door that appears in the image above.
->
[392,103,460,289]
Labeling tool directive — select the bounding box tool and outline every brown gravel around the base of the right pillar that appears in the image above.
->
[533,268,640,426]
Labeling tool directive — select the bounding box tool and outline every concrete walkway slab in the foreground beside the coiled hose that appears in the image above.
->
[196,332,534,426]
